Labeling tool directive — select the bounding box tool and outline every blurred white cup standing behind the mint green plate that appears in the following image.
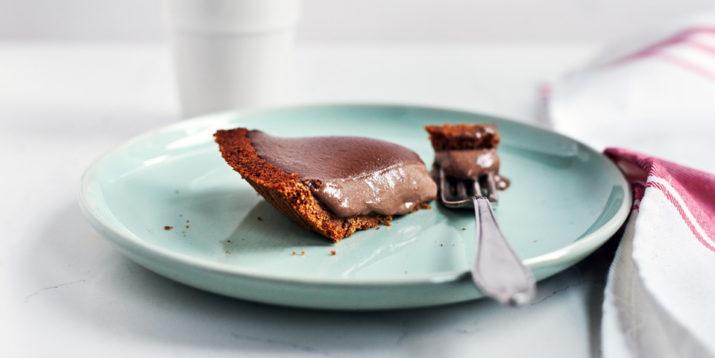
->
[165,0,300,117]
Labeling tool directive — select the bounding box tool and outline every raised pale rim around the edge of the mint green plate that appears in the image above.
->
[77,102,632,287]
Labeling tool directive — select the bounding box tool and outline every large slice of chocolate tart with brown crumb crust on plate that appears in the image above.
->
[214,128,437,242]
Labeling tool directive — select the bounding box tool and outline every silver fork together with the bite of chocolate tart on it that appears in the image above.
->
[425,124,536,306]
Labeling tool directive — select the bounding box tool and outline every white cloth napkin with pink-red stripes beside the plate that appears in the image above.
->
[546,16,715,357]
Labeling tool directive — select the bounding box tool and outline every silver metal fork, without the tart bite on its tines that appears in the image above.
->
[439,168,536,306]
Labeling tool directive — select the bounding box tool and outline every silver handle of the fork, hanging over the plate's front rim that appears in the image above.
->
[472,196,536,306]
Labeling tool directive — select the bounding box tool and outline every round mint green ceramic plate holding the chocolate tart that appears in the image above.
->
[80,105,630,309]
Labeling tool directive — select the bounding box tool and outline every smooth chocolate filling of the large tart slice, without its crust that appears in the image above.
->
[248,131,437,217]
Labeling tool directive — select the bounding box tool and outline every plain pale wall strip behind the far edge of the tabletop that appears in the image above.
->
[0,0,715,43]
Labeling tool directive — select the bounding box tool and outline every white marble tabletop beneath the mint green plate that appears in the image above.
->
[0,43,612,357]
